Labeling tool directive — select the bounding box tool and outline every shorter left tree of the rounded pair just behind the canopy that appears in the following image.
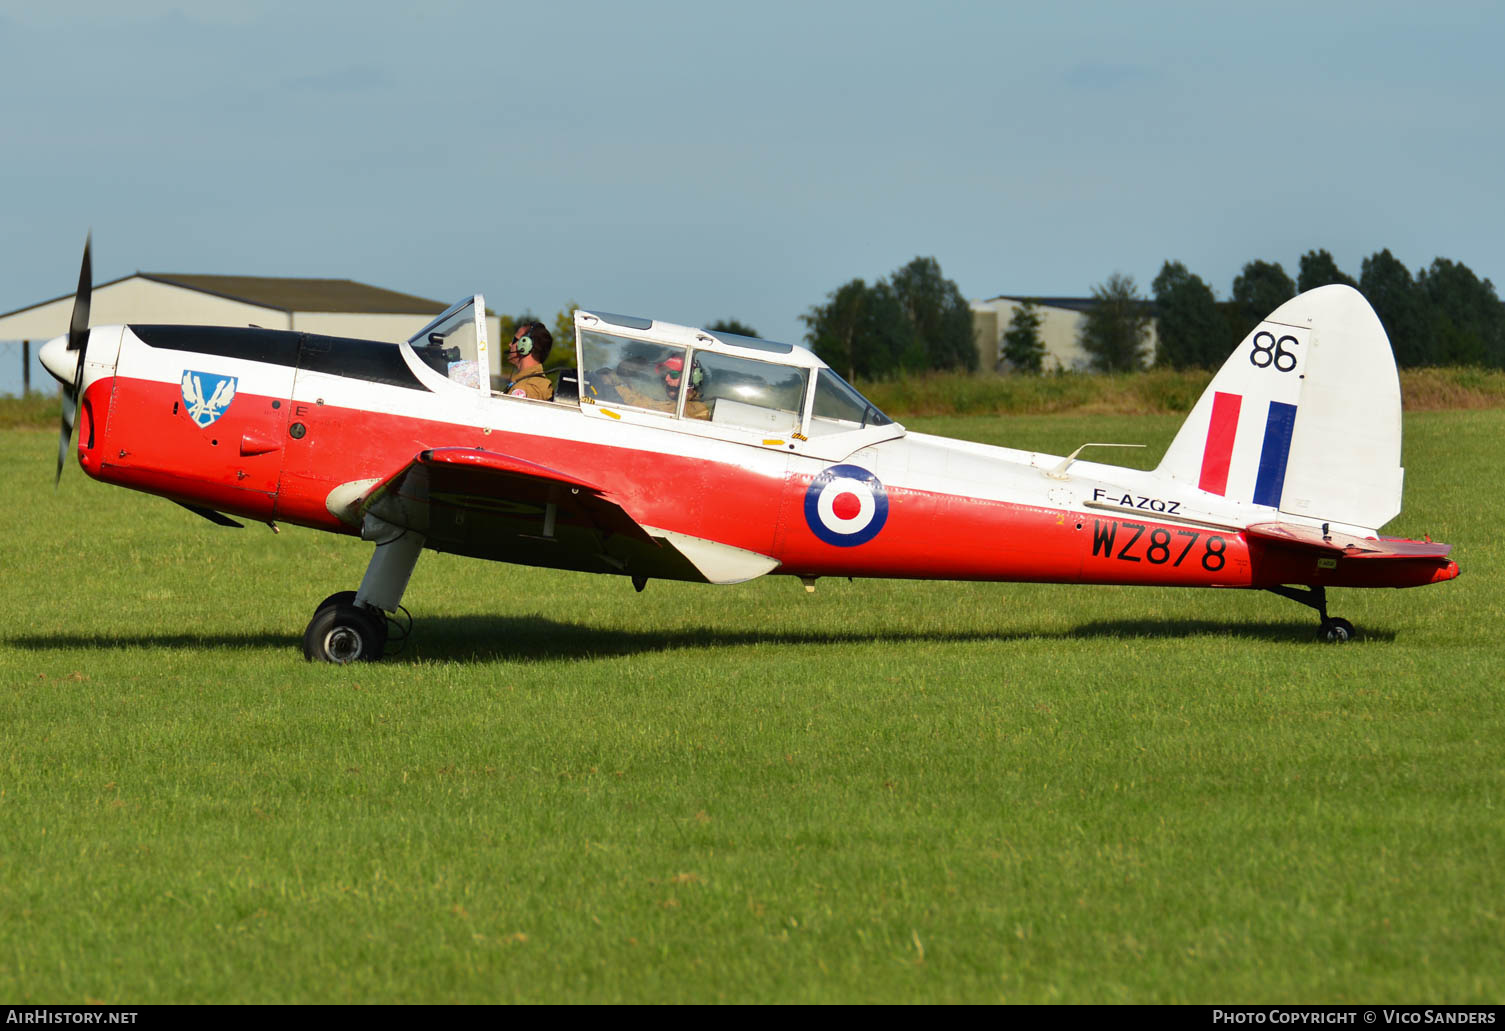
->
[799,278,924,379]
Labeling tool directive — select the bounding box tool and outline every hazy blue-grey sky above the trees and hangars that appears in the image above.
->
[0,0,1505,342]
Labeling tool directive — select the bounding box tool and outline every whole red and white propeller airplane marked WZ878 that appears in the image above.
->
[41,241,1458,664]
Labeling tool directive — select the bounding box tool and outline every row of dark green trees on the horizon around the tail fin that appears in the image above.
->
[799,250,1505,379]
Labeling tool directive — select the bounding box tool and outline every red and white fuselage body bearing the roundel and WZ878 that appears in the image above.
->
[55,327,1437,587]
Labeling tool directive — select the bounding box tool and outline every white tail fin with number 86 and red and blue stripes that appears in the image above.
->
[1157,286,1403,530]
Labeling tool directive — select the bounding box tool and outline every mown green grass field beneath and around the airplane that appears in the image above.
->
[0,409,1505,1002]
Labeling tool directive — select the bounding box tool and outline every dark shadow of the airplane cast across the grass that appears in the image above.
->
[5,616,1395,662]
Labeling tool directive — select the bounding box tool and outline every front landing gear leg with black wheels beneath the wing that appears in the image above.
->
[303,516,423,665]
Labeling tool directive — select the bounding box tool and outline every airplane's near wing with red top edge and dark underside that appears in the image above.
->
[328,447,764,582]
